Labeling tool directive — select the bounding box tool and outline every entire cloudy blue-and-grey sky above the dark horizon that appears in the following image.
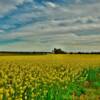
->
[0,0,100,52]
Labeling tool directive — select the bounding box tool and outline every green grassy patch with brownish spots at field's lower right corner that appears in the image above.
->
[37,68,100,100]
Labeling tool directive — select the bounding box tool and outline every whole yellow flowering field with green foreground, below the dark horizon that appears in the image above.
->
[0,54,100,100]
